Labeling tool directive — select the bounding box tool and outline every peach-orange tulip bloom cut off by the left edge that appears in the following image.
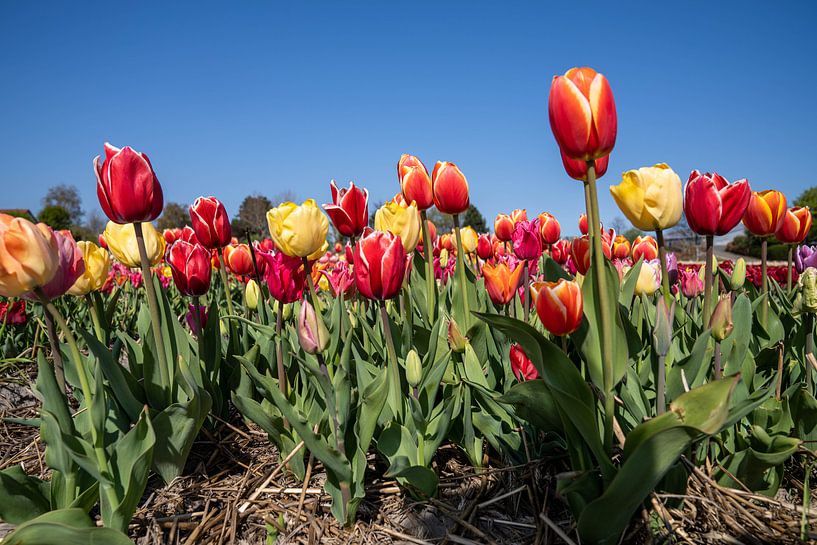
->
[0,214,60,297]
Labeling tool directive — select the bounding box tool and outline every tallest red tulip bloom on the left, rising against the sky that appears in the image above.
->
[94,142,164,223]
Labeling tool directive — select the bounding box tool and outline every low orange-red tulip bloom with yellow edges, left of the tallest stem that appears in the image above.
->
[533,278,584,336]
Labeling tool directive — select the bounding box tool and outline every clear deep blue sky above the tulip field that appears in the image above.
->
[0,1,817,236]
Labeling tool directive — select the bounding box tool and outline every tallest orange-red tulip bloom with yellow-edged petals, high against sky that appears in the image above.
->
[548,68,616,161]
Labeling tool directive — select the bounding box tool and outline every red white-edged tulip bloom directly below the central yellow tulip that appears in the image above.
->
[354,231,406,301]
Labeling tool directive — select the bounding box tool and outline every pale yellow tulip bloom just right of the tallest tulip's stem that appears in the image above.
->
[610,163,684,231]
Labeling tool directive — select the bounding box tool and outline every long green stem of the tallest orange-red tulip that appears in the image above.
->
[585,160,616,454]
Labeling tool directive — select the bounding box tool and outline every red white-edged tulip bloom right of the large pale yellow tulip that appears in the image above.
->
[684,170,752,235]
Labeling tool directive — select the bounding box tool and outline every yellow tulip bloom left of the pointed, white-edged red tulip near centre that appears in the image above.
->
[267,199,329,260]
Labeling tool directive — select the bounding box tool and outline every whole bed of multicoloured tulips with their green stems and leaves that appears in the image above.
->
[0,68,817,544]
